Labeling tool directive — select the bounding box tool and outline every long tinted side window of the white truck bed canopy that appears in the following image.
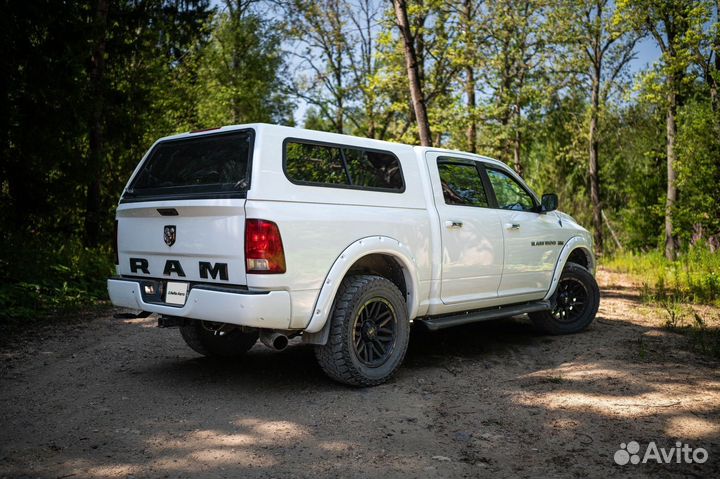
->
[285,141,405,192]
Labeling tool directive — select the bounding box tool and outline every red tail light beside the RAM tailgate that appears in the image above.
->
[245,219,285,274]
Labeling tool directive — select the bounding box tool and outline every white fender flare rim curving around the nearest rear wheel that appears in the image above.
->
[305,236,419,333]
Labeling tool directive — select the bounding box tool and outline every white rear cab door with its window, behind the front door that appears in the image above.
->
[426,152,504,308]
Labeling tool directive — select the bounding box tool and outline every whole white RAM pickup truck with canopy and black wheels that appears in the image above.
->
[108,124,600,386]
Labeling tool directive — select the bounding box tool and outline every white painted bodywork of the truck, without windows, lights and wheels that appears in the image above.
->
[108,124,594,333]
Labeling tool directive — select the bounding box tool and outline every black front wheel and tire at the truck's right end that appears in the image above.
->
[529,263,600,335]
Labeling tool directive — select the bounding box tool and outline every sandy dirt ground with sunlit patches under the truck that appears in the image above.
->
[0,272,720,478]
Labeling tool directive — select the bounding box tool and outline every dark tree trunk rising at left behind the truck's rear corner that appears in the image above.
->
[84,0,109,246]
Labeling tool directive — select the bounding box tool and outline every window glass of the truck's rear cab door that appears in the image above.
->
[438,160,490,208]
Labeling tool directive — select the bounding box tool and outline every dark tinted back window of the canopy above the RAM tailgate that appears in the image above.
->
[123,130,252,200]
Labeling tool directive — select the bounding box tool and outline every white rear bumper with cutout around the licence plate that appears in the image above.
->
[107,278,291,329]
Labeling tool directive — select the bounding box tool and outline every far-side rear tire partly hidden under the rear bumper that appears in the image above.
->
[180,321,258,358]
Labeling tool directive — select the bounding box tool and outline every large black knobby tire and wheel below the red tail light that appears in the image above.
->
[315,275,410,386]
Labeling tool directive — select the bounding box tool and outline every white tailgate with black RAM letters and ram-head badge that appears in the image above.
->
[117,199,247,285]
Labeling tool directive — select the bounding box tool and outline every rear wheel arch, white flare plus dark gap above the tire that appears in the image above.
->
[303,236,419,336]
